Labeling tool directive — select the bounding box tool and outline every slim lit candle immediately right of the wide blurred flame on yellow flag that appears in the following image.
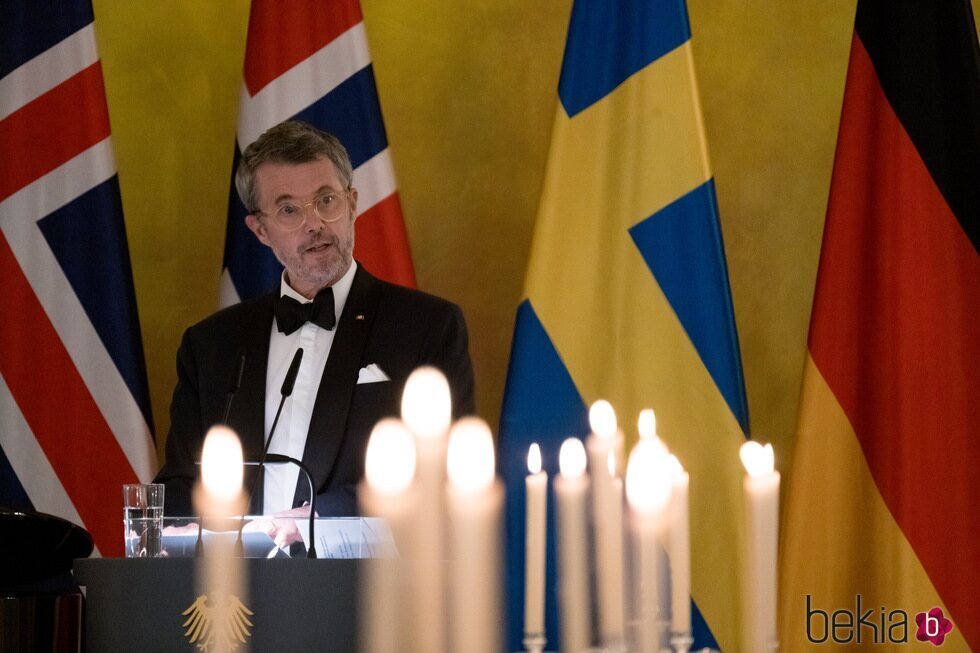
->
[667,455,691,636]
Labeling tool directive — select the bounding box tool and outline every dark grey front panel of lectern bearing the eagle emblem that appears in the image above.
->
[73,558,357,653]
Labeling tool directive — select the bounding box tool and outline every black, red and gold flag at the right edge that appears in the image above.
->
[780,0,980,651]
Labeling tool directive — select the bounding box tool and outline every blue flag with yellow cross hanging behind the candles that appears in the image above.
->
[500,0,748,650]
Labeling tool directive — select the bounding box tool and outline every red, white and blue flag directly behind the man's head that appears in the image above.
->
[220,0,415,306]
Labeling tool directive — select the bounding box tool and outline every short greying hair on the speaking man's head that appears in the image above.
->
[235,120,354,214]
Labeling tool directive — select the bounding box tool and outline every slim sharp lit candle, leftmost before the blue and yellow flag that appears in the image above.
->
[524,442,548,651]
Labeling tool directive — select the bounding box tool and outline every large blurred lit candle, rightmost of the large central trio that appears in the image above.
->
[446,417,503,653]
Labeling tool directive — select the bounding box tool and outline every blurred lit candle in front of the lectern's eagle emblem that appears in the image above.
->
[193,426,245,653]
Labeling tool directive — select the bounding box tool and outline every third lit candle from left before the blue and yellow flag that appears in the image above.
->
[587,399,623,648]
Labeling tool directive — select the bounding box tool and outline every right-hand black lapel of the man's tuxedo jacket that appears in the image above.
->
[294,266,381,505]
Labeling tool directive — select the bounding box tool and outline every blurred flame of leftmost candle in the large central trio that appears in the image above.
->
[364,417,415,496]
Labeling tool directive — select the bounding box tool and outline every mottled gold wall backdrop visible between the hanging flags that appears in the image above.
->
[94,0,928,470]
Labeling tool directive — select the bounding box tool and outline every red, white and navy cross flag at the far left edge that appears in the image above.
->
[0,0,156,556]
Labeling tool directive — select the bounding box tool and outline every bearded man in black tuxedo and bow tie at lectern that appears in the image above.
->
[156,121,474,528]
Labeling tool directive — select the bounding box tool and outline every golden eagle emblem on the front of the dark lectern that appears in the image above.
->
[181,592,255,652]
